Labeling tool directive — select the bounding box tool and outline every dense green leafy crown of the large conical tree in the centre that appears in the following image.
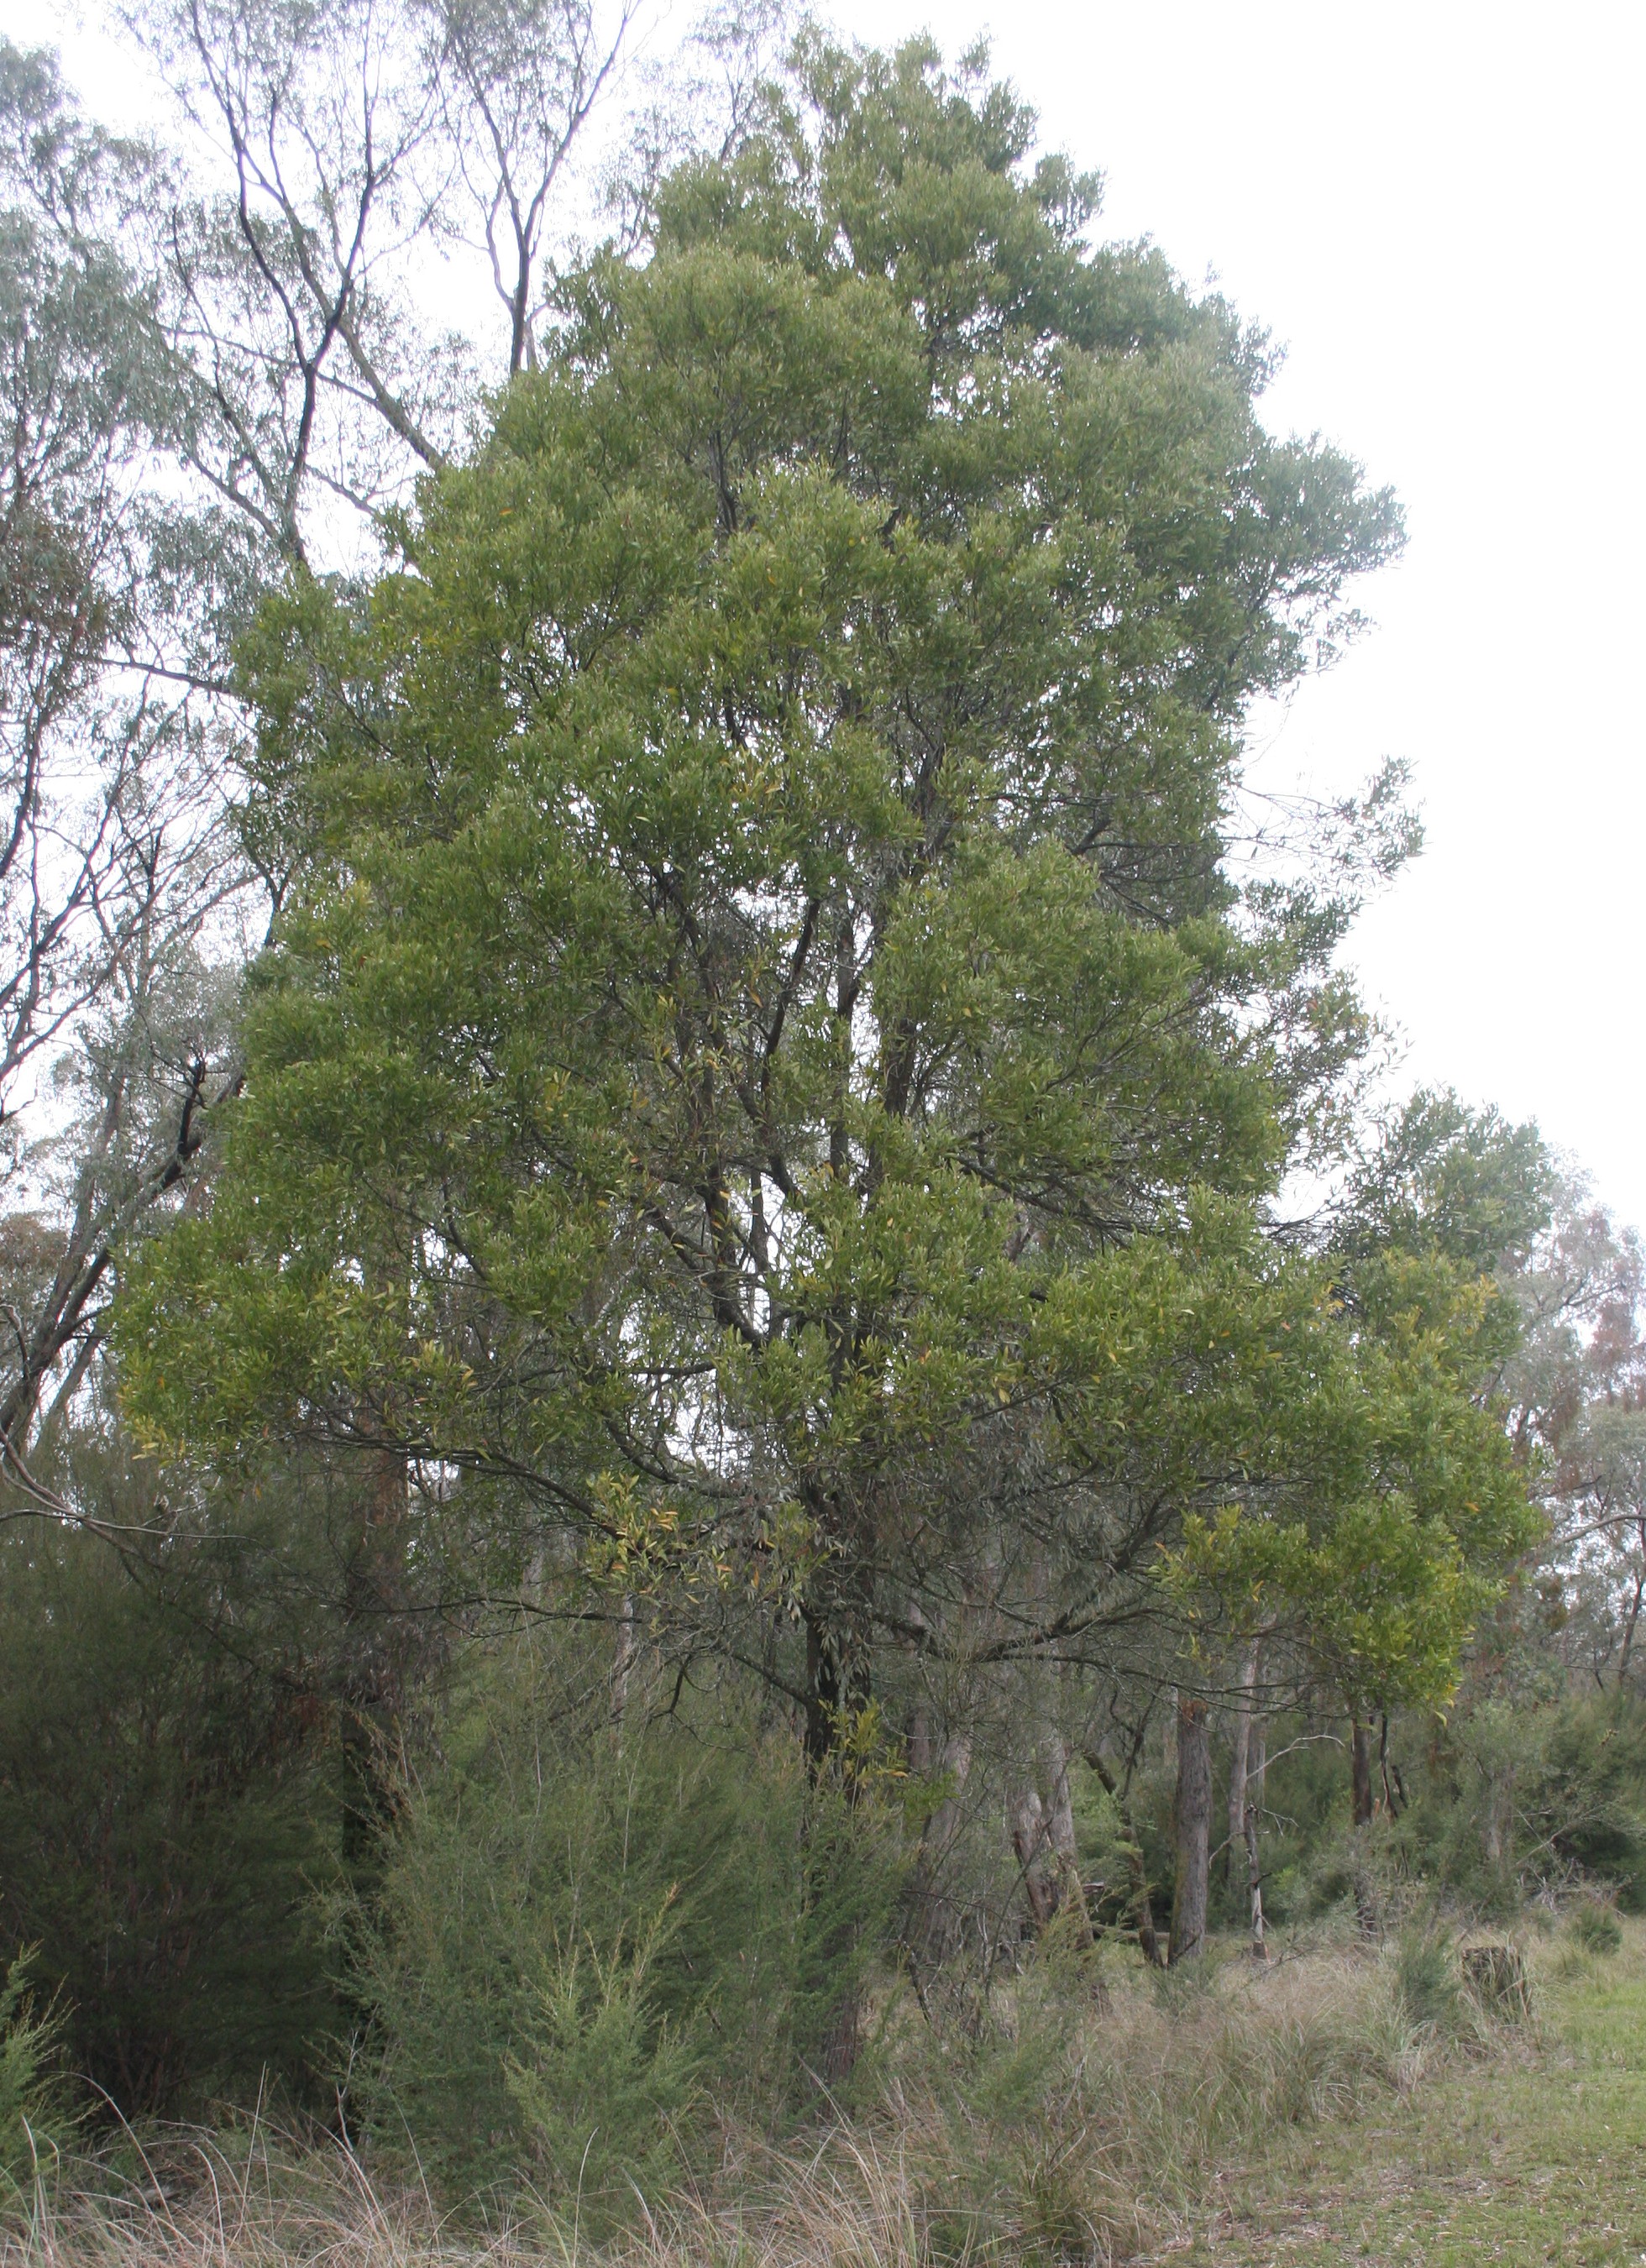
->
[123,43,1533,1757]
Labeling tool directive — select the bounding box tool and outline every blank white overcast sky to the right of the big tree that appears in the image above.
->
[35,0,1646,1227]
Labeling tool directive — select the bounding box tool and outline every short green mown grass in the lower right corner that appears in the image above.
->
[1161,1930,1646,2268]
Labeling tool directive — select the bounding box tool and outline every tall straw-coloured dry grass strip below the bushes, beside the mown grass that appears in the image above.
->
[0,1953,1469,2268]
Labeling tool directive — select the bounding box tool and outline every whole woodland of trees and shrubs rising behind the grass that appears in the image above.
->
[0,0,1646,2211]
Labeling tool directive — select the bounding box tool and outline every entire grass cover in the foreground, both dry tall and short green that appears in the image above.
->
[0,1925,1646,2268]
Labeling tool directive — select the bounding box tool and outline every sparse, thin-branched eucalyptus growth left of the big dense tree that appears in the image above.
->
[0,0,698,1451]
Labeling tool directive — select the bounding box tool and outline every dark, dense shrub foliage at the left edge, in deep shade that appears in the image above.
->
[0,1460,338,2113]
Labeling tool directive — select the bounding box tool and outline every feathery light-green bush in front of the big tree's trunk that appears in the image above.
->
[344,1635,902,2223]
